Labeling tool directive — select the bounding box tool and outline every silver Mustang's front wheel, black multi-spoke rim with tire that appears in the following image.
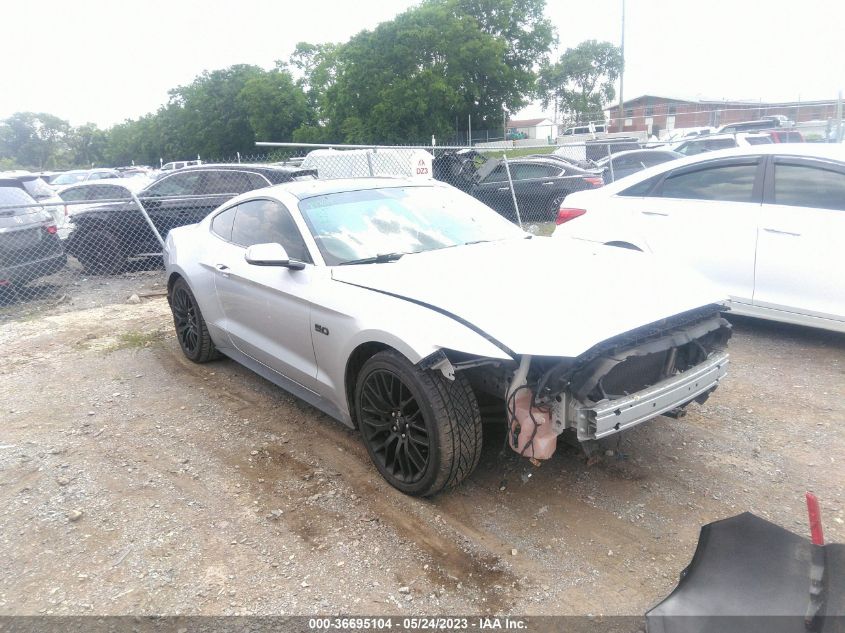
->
[355,350,481,496]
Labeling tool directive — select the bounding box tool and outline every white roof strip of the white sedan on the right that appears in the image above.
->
[595,144,845,193]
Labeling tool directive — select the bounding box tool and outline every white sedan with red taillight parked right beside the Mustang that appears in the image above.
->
[554,143,845,331]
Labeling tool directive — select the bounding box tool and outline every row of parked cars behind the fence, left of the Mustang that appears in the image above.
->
[0,164,314,284]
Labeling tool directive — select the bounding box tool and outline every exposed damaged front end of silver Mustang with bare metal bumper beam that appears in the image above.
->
[448,304,731,462]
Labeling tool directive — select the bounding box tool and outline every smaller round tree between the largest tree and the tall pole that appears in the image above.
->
[538,40,622,123]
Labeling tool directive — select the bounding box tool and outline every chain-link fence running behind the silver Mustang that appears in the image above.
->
[0,125,836,319]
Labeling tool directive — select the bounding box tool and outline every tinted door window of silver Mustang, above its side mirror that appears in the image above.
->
[231,200,313,264]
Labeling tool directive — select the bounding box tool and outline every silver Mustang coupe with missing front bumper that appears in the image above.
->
[165,178,730,495]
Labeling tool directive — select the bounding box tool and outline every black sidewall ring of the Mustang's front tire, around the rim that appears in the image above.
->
[355,352,443,495]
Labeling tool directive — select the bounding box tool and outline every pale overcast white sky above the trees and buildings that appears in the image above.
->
[0,0,845,127]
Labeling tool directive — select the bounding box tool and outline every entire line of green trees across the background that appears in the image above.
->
[0,0,621,169]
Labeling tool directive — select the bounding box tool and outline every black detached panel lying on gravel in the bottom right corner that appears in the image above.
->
[646,512,845,633]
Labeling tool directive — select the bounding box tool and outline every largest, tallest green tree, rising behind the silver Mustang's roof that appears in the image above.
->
[295,0,554,143]
